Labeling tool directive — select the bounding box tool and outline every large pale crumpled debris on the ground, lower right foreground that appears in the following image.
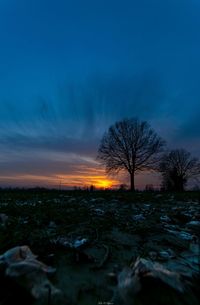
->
[112,258,198,305]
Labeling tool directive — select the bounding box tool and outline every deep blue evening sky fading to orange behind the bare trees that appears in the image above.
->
[0,0,200,188]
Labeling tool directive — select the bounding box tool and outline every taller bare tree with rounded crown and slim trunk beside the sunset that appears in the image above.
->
[97,118,164,190]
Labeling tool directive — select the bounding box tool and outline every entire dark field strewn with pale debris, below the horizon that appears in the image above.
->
[0,190,200,305]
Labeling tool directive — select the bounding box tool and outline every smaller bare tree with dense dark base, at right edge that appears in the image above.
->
[159,149,200,191]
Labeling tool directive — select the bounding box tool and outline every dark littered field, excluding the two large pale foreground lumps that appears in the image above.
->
[0,190,200,305]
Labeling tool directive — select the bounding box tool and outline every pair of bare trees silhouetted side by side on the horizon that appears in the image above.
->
[97,118,200,191]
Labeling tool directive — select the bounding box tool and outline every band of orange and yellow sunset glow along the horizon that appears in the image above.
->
[0,166,159,189]
